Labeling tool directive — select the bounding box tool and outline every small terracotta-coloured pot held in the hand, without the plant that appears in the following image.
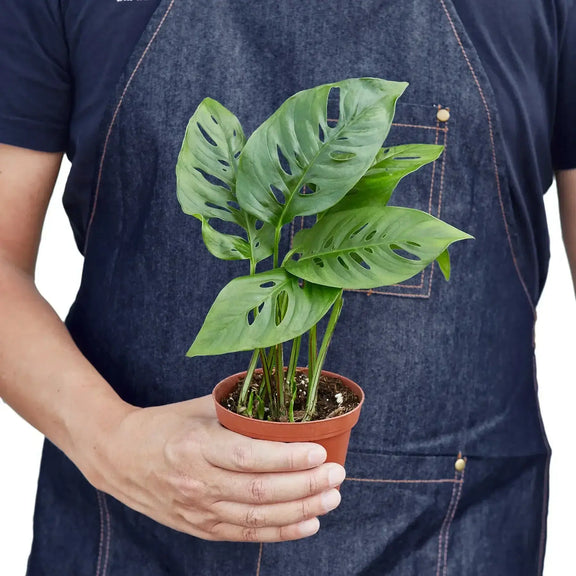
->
[212,368,364,466]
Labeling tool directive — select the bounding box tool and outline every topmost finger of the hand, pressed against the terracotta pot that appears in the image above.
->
[204,428,326,472]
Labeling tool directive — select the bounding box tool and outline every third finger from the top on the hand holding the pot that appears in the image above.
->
[211,488,341,528]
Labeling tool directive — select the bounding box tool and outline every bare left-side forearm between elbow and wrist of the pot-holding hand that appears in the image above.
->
[0,259,133,482]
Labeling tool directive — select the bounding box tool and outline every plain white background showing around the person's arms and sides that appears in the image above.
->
[0,163,576,576]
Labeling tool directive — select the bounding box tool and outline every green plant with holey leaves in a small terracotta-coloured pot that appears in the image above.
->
[176,78,471,464]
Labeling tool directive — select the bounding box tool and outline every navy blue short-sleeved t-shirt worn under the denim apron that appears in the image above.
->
[0,0,576,292]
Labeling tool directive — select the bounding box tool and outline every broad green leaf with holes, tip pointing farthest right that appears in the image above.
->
[283,206,472,289]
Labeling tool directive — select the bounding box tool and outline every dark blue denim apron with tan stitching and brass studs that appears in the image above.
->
[28,0,550,576]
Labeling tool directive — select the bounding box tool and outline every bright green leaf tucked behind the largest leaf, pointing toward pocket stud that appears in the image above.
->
[326,144,444,214]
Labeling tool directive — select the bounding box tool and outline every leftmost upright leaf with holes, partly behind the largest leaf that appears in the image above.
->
[176,98,274,262]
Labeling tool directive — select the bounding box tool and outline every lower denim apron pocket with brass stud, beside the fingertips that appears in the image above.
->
[259,452,464,576]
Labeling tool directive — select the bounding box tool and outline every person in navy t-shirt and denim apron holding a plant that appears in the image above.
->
[0,0,576,576]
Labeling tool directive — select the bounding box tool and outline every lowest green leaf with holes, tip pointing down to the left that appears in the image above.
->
[187,268,340,356]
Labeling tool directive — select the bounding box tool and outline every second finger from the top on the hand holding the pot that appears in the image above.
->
[211,462,346,504]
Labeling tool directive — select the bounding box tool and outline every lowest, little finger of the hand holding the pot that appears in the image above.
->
[201,518,320,542]
